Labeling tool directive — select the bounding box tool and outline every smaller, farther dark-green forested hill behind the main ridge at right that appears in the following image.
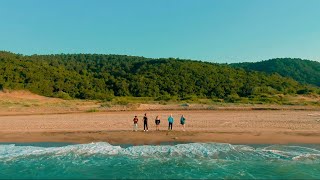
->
[231,58,320,86]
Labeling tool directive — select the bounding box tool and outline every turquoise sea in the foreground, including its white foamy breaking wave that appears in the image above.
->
[0,142,320,179]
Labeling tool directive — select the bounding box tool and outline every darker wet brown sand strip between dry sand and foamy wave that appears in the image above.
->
[0,130,320,145]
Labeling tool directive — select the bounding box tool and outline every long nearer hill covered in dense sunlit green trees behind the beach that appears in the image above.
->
[0,52,316,99]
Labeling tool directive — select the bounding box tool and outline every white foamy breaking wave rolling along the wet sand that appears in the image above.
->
[0,142,320,161]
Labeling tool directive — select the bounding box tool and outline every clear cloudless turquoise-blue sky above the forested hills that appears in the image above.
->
[0,0,320,63]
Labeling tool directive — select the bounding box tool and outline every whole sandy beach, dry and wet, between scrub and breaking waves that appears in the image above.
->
[0,110,320,144]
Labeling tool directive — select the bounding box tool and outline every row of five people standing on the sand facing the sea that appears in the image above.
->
[133,113,186,131]
